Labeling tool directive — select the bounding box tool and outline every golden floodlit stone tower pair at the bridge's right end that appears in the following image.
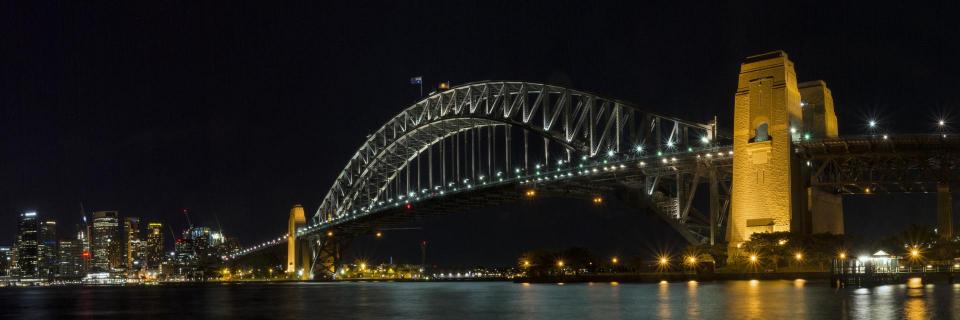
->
[727,51,843,248]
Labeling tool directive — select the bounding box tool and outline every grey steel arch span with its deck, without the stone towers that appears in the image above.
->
[230,81,732,273]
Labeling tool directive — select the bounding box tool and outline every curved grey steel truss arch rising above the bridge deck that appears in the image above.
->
[314,81,716,223]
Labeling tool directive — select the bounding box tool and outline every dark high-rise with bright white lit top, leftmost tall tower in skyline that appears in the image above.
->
[12,212,40,279]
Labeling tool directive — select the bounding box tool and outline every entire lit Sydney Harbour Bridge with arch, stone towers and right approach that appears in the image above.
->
[226,51,960,279]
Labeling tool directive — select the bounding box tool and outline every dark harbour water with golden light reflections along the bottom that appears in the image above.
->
[0,280,960,320]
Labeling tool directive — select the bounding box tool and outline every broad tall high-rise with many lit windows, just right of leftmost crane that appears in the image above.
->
[91,211,124,272]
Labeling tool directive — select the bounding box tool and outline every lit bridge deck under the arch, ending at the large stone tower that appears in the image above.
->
[228,146,733,259]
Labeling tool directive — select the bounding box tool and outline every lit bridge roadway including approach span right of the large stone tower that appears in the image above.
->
[227,134,960,259]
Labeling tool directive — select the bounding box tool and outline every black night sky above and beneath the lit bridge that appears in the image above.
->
[0,1,960,263]
